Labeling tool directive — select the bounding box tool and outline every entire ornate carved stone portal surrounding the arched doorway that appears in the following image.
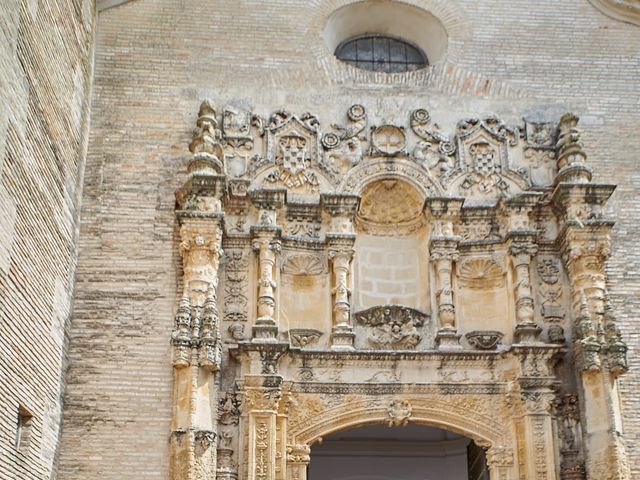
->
[167,101,629,480]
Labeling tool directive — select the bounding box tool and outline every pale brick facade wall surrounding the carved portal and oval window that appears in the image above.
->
[59,0,640,480]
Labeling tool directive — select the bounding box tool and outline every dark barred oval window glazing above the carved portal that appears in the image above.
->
[335,34,429,73]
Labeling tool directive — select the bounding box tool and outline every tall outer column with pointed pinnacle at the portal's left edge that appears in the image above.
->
[171,101,225,480]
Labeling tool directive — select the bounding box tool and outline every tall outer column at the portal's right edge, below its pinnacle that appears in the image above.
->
[552,174,630,480]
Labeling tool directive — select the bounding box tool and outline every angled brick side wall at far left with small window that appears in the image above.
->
[0,0,95,479]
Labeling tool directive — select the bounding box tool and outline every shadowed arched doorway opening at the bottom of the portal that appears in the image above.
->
[307,424,489,480]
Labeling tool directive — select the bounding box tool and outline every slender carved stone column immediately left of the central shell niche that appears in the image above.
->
[321,194,359,350]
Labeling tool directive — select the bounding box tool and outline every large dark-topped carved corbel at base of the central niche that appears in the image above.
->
[355,305,429,350]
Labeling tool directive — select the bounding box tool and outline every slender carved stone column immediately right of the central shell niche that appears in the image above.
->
[425,198,464,350]
